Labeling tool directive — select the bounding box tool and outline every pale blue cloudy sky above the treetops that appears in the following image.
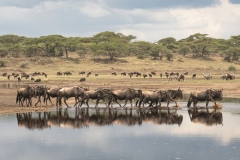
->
[0,0,240,42]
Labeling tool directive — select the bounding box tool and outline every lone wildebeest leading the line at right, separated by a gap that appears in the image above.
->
[187,89,223,108]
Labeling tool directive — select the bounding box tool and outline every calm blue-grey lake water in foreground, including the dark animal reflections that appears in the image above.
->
[0,99,240,160]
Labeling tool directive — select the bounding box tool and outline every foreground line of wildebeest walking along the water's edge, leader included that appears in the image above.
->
[16,85,223,108]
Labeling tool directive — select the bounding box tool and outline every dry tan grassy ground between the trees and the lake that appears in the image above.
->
[0,55,240,114]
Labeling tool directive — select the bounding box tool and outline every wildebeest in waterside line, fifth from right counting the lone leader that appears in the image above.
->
[79,88,112,108]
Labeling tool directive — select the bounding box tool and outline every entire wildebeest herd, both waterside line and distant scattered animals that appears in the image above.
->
[0,71,232,107]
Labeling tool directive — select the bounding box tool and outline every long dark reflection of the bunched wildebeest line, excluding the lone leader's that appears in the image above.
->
[17,108,183,129]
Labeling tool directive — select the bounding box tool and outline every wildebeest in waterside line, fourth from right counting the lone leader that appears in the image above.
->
[111,88,142,107]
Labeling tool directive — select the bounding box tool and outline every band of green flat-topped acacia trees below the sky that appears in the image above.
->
[0,31,240,62]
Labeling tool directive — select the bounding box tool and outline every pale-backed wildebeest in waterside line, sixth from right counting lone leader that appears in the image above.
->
[58,86,86,107]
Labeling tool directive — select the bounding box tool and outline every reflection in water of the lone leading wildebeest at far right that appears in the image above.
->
[188,108,223,126]
